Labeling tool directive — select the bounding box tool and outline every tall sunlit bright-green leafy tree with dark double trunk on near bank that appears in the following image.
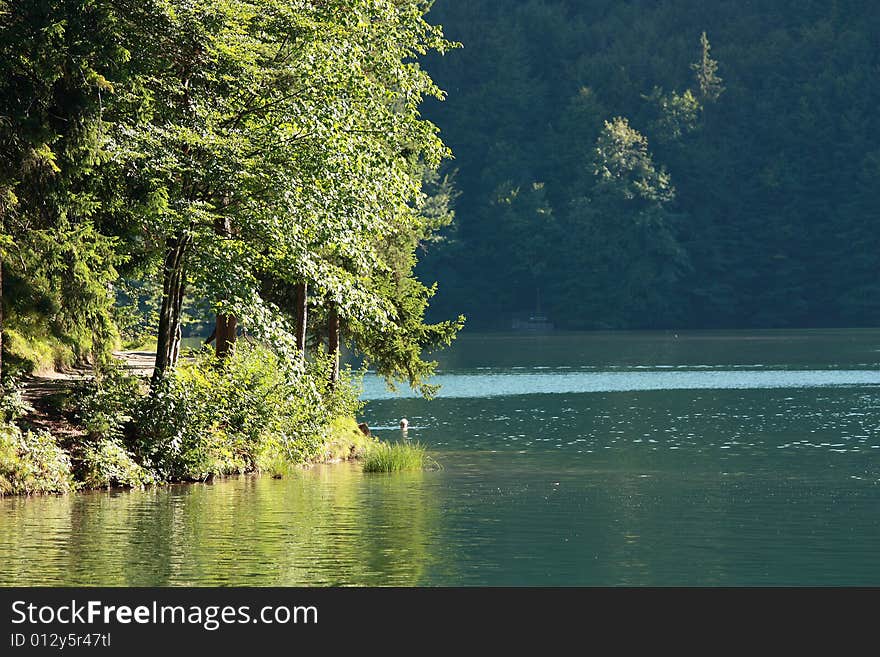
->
[109,0,458,377]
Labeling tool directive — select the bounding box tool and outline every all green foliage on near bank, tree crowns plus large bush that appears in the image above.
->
[0,0,463,494]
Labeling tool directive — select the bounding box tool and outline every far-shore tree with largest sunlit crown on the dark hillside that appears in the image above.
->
[556,117,687,328]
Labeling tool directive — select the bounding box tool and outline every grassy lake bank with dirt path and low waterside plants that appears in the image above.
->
[0,351,378,498]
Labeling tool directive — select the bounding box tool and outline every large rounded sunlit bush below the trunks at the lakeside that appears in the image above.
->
[133,344,358,480]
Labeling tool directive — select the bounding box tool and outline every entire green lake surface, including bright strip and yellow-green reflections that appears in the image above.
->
[0,331,880,586]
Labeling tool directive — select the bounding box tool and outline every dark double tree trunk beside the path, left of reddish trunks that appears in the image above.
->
[153,234,192,383]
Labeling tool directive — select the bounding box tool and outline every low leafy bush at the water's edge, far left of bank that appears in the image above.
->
[0,424,74,495]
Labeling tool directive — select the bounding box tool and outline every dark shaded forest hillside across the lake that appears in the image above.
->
[419,0,880,329]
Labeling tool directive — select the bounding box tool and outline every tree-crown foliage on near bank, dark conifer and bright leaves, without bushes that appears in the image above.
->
[0,0,460,384]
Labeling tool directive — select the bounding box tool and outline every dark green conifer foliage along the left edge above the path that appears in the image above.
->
[0,0,128,368]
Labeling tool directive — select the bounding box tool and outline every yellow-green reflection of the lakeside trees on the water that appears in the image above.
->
[0,465,440,586]
